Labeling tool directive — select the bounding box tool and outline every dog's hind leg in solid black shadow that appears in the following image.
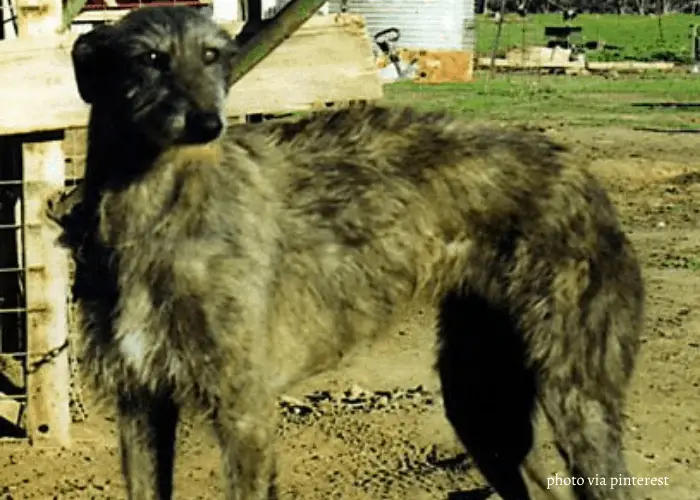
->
[437,293,535,500]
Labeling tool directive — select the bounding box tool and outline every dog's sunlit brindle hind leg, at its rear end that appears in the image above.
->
[534,259,643,500]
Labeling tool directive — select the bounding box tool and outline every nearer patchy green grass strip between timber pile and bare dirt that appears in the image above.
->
[383,71,700,129]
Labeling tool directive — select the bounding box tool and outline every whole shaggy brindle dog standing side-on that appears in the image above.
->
[46,7,644,500]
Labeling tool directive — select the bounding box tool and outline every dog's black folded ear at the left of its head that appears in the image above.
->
[71,25,114,104]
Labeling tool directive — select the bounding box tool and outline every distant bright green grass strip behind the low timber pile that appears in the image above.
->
[477,14,700,63]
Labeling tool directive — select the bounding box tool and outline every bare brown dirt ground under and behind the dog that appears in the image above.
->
[0,128,700,500]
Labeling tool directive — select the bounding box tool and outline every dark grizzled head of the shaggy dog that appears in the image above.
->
[71,7,238,148]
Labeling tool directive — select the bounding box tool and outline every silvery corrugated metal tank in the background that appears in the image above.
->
[328,0,476,51]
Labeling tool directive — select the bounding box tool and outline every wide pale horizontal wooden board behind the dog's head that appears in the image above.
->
[0,14,382,135]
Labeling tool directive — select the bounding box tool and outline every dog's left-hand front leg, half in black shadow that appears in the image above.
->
[117,394,179,500]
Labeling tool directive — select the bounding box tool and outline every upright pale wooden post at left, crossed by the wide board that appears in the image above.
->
[18,0,70,446]
